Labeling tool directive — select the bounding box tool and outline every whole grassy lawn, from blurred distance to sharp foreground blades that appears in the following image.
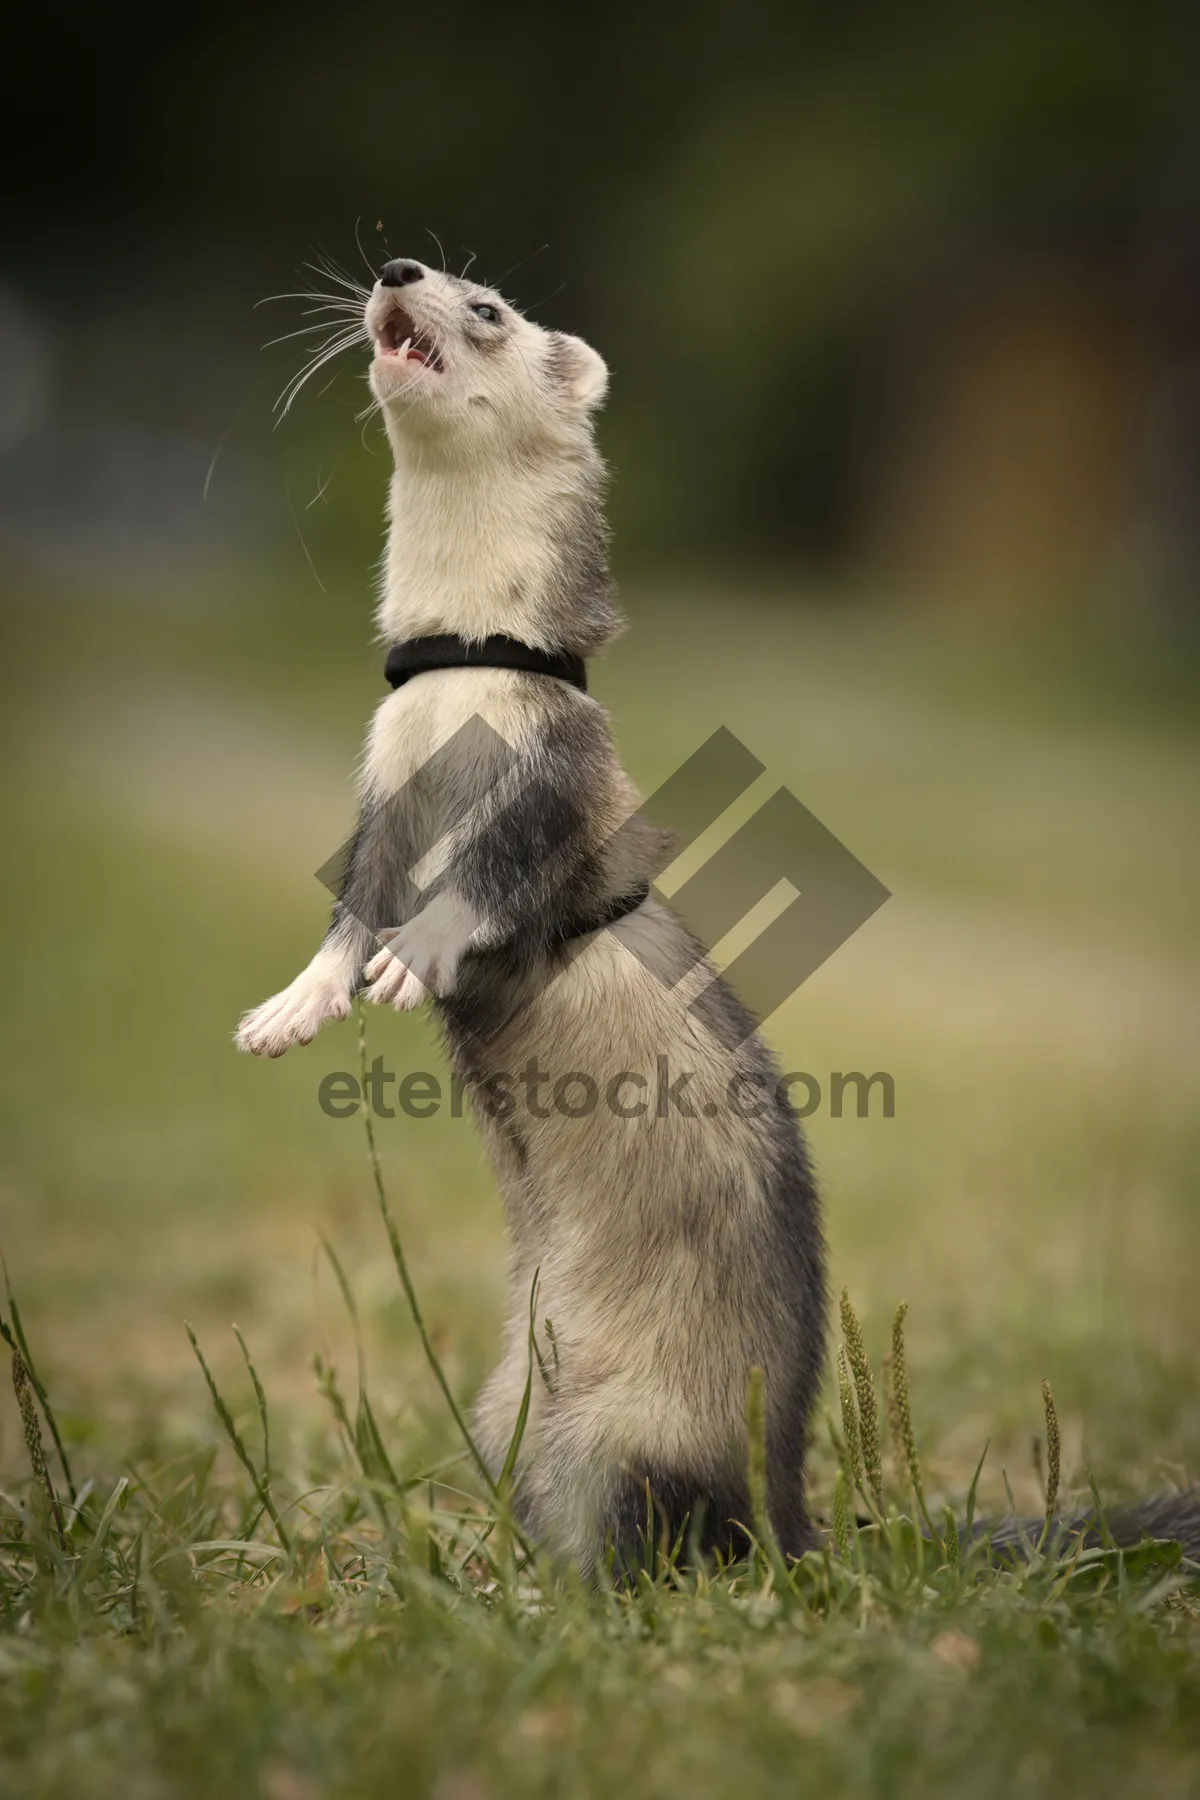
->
[0,565,1200,1800]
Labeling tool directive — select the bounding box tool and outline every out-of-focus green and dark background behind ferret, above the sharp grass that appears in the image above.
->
[0,0,1200,1505]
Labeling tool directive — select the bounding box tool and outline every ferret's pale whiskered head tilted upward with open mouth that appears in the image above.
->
[365,257,608,454]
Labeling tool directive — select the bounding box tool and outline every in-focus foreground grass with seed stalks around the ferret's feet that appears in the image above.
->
[0,1209,1200,1800]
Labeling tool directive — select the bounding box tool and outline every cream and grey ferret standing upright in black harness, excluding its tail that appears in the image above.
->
[236,259,826,1573]
